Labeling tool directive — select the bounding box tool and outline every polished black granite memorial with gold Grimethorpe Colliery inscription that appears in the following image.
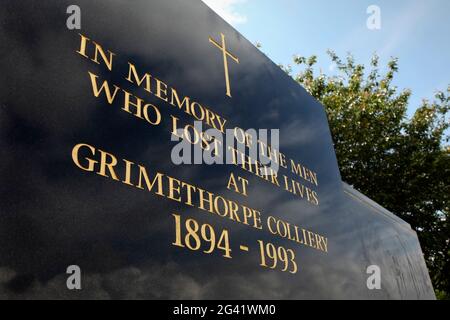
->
[0,0,435,299]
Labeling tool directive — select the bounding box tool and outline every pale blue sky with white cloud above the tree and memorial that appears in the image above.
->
[203,0,450,116]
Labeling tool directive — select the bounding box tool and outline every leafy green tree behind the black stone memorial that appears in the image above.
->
[282,51,450,298]
